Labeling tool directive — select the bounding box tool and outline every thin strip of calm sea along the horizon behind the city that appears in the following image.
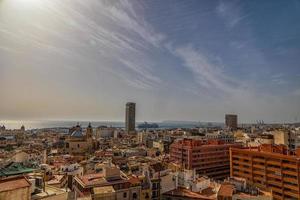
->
[0,120,211,129]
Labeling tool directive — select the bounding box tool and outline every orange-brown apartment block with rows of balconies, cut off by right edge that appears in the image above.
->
[230,144,300,200]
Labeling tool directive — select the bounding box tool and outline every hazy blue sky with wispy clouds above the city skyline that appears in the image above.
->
[0,0,300,123]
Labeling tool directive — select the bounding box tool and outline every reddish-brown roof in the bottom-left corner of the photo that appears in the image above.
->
[0,176,31,192]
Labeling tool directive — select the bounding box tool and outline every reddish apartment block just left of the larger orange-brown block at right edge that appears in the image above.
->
[170,138,240,179]
